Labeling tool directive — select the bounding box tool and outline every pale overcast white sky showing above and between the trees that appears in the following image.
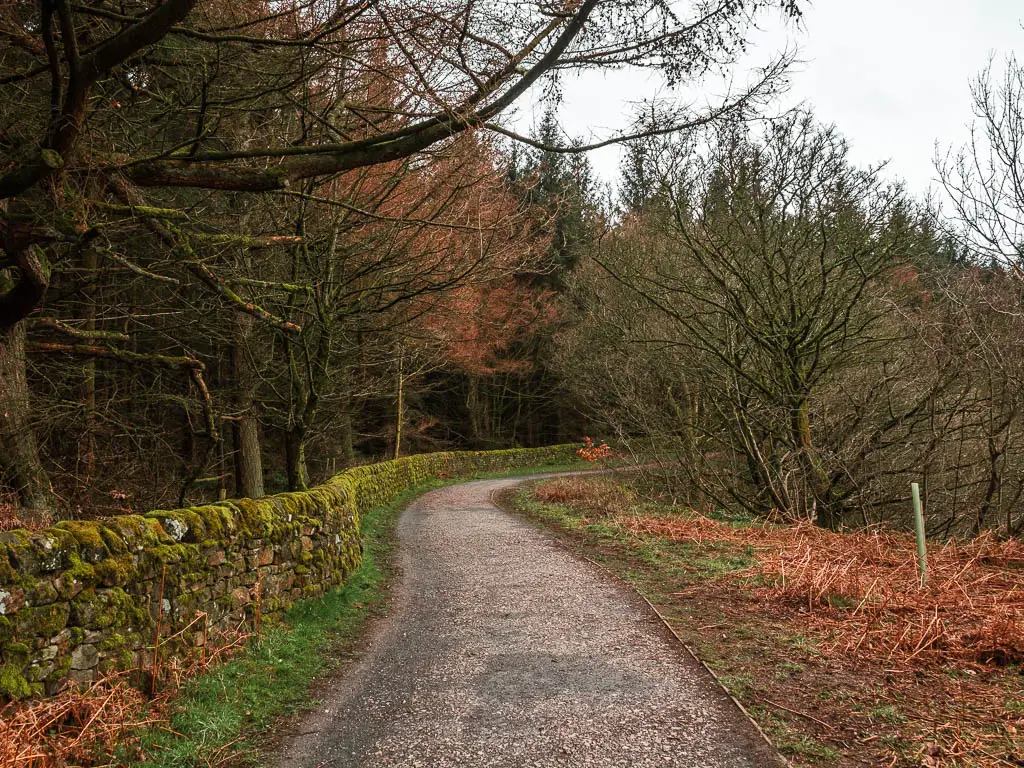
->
[518,0,1024,195]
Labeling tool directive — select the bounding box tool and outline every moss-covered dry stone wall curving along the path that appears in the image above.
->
[0,445,575,699]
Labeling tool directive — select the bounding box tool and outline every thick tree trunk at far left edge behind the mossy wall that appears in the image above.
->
[0,323,56,522]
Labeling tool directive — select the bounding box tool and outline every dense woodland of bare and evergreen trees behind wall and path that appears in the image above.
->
[0,0,1024,548]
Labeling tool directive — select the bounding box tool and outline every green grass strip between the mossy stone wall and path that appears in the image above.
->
[129,465,581,768]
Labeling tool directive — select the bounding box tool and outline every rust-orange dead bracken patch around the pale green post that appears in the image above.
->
[622,515,1024,665]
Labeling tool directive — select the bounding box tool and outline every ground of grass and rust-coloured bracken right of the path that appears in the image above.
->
[506,477,1024,767]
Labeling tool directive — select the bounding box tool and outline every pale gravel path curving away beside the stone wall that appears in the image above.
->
[275,478,784,768]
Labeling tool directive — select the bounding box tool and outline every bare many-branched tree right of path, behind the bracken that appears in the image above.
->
[569,113,907,527]
